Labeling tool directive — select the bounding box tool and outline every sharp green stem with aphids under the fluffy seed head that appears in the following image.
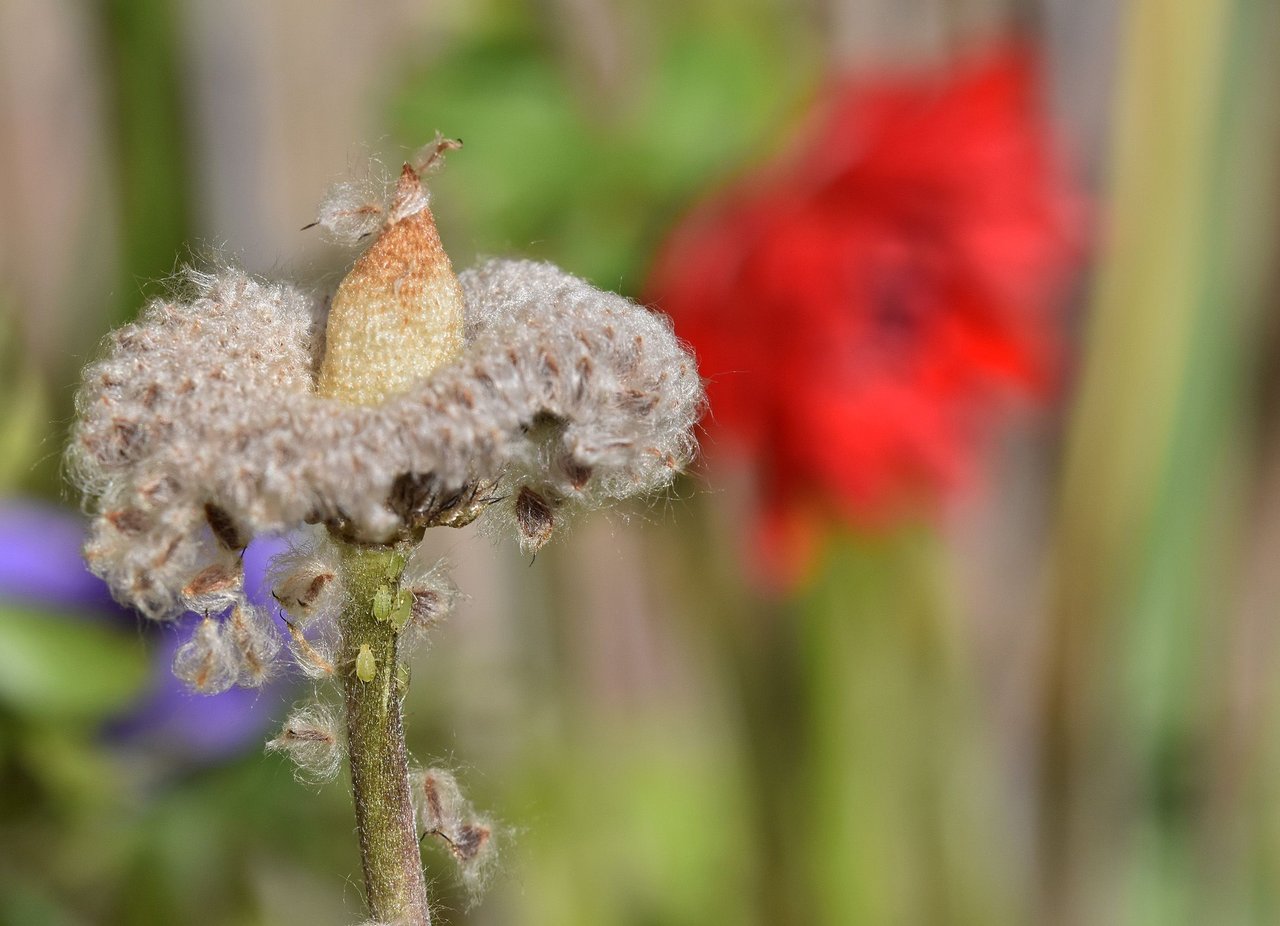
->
[339,546,431,926]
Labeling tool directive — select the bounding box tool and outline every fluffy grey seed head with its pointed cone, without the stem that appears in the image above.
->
[68,146,703,622]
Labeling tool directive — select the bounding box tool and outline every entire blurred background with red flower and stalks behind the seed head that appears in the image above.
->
[0,0,1280,926]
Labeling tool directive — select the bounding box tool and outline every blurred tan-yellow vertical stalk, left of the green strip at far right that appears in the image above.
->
[1039,0,1234,923]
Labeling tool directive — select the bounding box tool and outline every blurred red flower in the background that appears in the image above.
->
[646,46,1082,584]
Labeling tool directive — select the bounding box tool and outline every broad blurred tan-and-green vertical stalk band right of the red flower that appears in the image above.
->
[1039,0,1242,923]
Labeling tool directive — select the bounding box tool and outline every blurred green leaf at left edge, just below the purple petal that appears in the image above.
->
[0,605,147,720]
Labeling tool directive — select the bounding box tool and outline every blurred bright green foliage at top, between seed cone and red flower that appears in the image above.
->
[392,10,813,292]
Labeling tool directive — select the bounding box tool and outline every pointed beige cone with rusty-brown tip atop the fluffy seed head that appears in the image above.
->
[316,164,463,405]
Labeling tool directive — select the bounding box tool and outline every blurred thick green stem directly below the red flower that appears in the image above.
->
[795,528,1021,923]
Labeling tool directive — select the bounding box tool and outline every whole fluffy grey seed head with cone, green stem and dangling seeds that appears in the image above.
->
[68,137,703,923]
